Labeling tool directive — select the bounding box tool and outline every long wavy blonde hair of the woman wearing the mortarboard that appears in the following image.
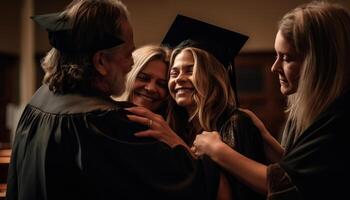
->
[167,47,236,143]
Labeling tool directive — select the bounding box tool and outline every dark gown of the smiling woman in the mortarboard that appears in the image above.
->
[219,109,266,200]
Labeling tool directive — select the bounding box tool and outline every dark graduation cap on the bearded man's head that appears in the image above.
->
[31,12,124,53]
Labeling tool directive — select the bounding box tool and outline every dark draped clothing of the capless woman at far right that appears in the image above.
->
[267,92,350,200]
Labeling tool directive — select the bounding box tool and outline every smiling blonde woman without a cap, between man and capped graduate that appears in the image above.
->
[114,45,169,114]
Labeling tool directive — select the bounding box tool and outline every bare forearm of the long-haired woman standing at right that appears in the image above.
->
[209,143,267,194]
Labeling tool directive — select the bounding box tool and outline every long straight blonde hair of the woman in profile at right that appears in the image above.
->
[279,1,350,133]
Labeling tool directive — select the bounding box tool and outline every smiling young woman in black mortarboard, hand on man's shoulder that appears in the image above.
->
[128,15,266,200]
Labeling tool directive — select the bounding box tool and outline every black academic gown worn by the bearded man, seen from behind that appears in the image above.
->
[7,85,219,200]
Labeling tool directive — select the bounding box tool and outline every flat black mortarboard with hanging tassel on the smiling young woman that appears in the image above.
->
[162,15,248,103]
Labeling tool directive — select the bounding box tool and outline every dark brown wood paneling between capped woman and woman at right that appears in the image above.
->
[235,52,285,138]
